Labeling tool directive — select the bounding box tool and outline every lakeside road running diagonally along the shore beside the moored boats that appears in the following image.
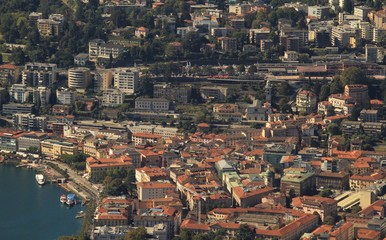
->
[45,160,100,203]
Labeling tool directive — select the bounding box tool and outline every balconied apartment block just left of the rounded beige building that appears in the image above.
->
[22,63,57,87]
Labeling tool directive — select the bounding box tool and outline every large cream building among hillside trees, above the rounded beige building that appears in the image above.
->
[88,39,124,62]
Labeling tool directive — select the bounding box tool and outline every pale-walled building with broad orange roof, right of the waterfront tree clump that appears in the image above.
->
[137,182,176,201]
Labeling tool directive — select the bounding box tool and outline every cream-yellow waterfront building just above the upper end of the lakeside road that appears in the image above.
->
[40,139,78,158]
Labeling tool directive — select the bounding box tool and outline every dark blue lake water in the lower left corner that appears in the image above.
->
[0,164,86,240]
